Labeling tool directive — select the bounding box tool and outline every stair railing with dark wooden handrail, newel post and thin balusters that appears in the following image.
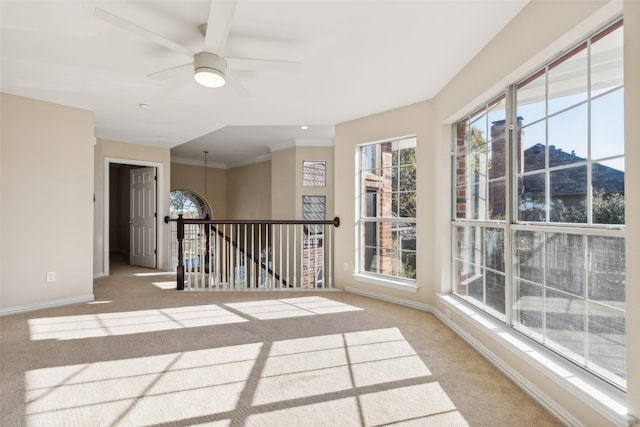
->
[165,215,340,290]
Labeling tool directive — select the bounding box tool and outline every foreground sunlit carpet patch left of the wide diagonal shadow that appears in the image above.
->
[25,343,262,426]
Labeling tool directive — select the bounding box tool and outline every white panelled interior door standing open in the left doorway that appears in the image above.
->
[129,167,156,268]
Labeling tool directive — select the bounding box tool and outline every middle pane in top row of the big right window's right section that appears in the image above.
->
[547,43,588,114]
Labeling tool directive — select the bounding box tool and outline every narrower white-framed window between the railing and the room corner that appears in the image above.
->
[357,137,416,280]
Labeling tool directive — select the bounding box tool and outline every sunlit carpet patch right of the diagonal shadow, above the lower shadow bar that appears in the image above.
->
[254,328,431,405]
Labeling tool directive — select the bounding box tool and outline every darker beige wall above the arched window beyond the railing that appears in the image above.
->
[171,163,228,219]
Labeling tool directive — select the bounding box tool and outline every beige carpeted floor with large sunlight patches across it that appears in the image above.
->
[0,266,559,427]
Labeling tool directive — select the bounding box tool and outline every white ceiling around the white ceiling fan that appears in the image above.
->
[0,0,527,167]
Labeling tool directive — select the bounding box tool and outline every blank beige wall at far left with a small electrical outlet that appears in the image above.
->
[0,94,95,314]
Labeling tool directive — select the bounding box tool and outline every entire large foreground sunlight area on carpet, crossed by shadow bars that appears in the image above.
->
[25,328,467,427]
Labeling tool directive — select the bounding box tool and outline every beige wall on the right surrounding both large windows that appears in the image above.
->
[335,0,640,426]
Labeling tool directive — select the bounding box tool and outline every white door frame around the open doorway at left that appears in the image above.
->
[102,157,165,276]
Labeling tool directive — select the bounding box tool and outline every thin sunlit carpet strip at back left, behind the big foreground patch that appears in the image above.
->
[29,304,248,341]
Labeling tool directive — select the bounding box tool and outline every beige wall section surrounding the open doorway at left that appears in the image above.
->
[93,139,171,277]
